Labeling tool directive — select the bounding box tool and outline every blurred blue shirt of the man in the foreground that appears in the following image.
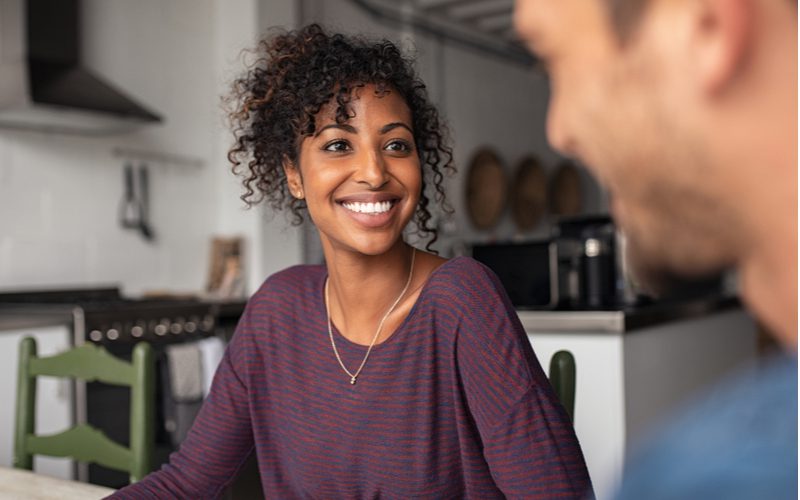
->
[616,355,797,500]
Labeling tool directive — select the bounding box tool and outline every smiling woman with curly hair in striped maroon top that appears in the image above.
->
[111,25,590,499]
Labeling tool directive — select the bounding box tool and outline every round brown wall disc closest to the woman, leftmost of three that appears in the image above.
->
[466,148,507,229]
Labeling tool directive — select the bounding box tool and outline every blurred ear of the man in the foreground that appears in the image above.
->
[694,0,758,93]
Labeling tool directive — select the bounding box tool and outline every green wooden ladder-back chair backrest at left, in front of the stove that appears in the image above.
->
[14,337,155,482]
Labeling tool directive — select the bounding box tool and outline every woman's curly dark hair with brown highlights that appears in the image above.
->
[228,24,455,250]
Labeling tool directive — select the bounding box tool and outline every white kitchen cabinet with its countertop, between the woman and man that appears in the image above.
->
[518,300,756,500]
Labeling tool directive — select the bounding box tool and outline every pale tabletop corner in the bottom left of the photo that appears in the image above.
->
[0,467,114,500]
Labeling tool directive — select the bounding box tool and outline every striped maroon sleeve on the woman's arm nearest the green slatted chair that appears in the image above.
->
[110,318,253,499]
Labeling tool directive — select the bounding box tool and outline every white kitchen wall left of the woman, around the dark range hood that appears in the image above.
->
[0,0,300,294]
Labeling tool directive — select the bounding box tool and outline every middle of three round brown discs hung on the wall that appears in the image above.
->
[511,156,547,231]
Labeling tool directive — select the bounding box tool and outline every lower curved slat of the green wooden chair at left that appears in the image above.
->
[25,424,132,470]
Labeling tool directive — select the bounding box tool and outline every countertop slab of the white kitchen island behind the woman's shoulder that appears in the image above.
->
[517,297,740,334]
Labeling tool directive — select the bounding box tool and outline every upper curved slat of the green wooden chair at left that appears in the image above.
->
[29,344,134,386]
